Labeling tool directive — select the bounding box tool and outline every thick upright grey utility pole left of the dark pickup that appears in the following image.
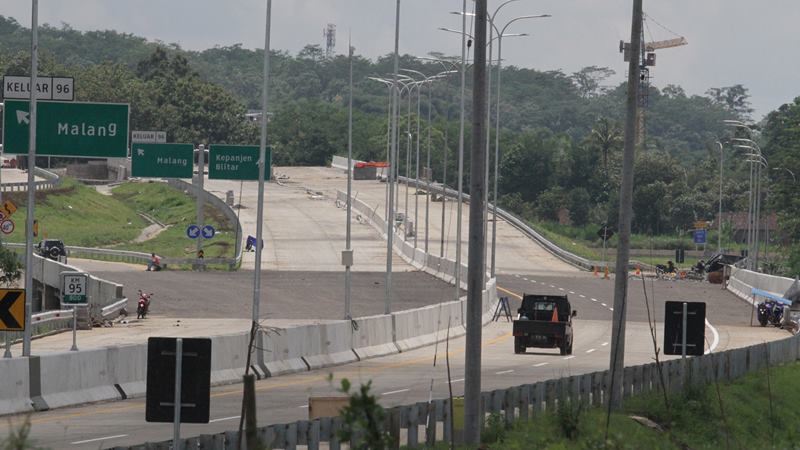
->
[464,0,488,447]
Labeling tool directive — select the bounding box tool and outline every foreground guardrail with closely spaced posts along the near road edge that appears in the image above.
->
[114,328,800,450]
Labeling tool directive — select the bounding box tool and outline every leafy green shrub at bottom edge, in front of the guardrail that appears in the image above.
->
[337,378,392,450]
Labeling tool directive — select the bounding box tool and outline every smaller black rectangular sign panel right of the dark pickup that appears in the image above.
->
[664,302,706,356]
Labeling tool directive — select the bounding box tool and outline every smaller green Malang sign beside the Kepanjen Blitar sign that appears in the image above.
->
[131,143,194,178]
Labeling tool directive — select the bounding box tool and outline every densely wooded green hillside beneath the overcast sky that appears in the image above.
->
[0,16,800,274]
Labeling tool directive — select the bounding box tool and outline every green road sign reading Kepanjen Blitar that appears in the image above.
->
[208,144,272,180]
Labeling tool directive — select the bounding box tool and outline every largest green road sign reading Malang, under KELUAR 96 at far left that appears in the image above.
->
[3,100,129,158]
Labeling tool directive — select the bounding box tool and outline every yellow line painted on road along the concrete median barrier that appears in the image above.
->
[25,286,522,425]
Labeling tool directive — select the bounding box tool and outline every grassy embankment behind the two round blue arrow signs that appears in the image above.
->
[4,178,235,258]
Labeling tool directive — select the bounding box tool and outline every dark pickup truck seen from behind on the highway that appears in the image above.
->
[513,295,578,355]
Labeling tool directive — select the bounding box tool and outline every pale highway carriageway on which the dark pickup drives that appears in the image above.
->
[4,274,788,449]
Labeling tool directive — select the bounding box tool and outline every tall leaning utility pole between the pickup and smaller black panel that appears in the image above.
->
[610,0,642,407]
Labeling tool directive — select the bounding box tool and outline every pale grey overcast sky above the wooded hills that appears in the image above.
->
[0,0,800,119]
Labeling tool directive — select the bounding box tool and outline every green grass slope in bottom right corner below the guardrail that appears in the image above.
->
[428,363,800,450]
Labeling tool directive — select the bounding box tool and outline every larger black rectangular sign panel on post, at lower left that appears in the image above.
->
[145,337,211,423]
